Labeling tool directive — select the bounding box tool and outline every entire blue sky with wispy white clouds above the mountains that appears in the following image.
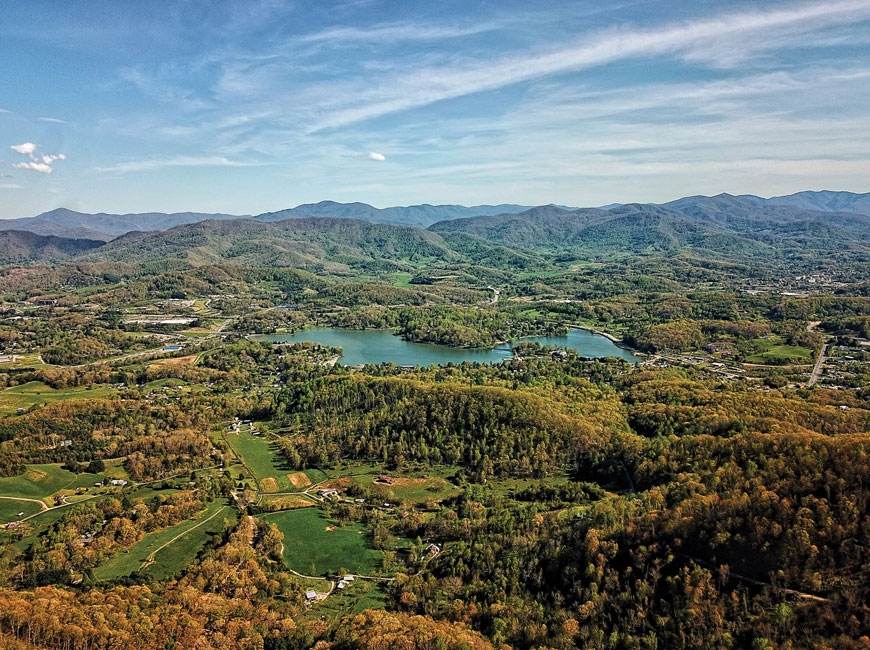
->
[0,0,870,218]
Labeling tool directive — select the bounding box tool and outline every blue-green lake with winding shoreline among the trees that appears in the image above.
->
[253,328,639,366]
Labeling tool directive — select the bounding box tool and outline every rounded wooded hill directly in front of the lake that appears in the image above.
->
[272,368,620,480]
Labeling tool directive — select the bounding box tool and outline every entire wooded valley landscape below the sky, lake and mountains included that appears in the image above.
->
[0,193,870,650]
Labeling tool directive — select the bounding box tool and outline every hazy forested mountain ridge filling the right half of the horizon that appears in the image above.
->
[429,194,870,260]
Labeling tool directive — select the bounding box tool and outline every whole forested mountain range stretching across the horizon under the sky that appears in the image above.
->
[0,191,870,271]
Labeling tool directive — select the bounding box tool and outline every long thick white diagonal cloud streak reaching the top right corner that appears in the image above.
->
[313,0,870,131]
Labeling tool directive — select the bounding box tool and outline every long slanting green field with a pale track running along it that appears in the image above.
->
[94,500,236,580]
